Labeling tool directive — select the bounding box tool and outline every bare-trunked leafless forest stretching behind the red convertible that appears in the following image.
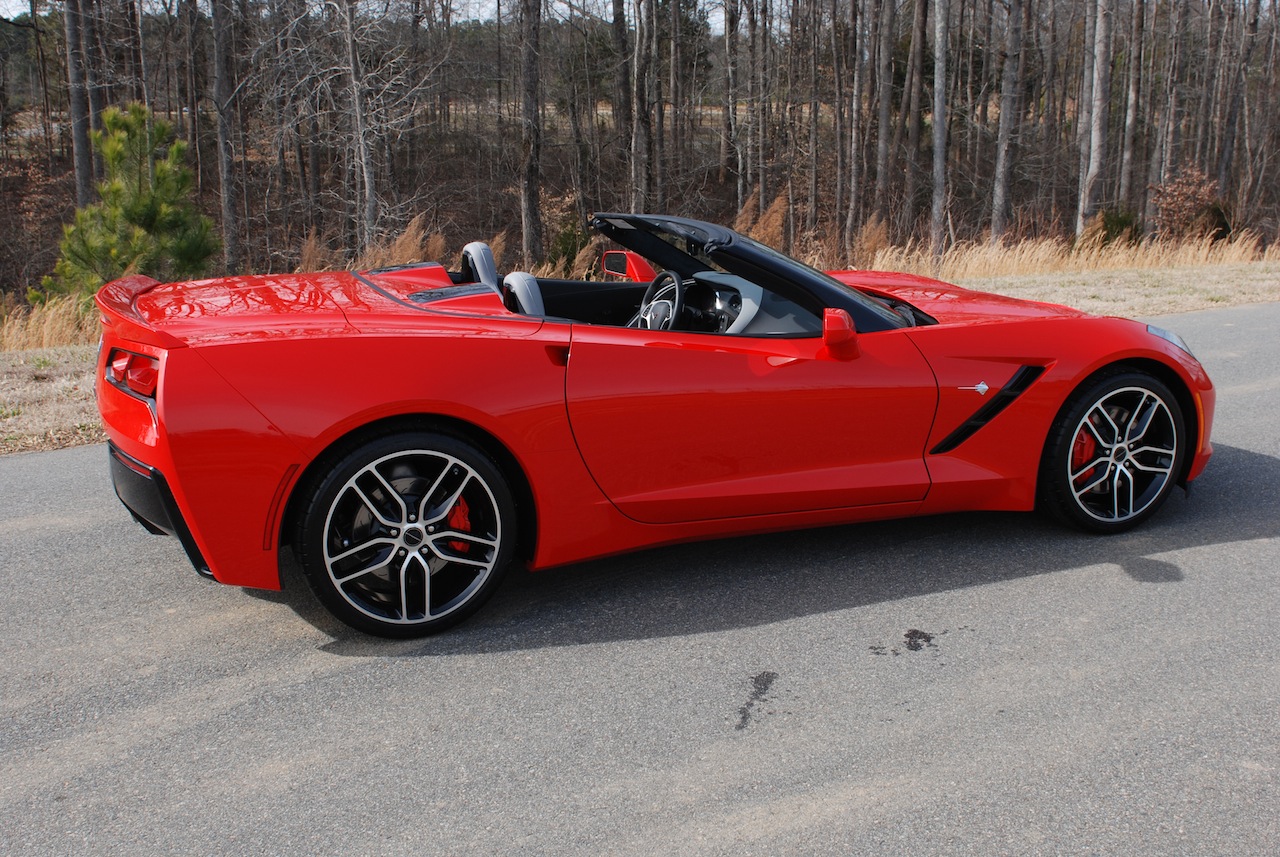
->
[0,0,1280,296]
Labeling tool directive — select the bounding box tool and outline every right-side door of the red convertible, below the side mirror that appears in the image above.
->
[566,325,937,523]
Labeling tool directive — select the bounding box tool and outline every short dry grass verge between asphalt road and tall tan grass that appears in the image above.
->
[0,262,1280,455]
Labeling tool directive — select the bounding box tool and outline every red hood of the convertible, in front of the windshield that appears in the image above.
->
[831,271,1089,324]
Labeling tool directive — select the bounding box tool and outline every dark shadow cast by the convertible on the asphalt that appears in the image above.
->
[278,446,1280,657]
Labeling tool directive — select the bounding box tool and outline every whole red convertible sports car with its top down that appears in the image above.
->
[97,214,1213,637]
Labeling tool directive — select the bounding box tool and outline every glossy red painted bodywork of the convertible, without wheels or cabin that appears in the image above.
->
[97,221,1213,624]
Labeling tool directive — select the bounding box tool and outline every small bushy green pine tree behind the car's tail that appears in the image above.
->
[28,104,219,303]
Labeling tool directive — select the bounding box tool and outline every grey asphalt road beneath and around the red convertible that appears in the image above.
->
[0,304,1280,857]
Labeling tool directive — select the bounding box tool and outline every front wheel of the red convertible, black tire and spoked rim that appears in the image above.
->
[1039,370,1187,533]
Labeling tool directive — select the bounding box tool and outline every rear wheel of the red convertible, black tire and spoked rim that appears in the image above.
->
[293,431,516,638]
